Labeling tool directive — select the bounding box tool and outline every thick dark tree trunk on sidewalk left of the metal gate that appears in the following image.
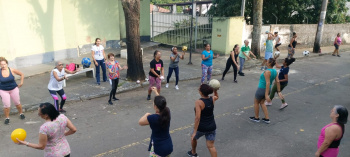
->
[122,0,145,81]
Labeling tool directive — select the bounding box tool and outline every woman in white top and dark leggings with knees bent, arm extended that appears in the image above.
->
[47,61,77,112]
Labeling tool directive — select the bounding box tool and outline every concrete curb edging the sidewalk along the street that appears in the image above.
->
[0,48,350,117]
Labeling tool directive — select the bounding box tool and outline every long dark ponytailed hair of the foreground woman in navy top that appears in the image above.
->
[154,96,170,128]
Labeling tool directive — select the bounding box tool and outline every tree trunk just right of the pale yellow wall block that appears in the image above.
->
[251,0,263,58]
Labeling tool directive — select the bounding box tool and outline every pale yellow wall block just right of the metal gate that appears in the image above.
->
[211,17,245,54]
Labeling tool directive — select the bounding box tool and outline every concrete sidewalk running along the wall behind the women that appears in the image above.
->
[0,43,350,116]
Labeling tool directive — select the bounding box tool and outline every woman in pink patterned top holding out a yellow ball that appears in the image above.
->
[17,103,77,157]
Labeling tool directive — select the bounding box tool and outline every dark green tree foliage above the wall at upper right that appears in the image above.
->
[209,0,350,24]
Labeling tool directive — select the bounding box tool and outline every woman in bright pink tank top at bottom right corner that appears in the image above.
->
[315,105,348,157]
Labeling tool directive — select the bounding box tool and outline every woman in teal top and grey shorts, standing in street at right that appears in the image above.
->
[249,58,283,124]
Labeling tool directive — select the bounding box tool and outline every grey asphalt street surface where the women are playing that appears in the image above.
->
[0,53,350,157]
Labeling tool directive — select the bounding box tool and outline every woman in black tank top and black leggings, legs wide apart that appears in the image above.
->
[221,44,239,83]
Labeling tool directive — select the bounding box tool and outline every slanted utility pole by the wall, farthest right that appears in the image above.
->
[313,0,328,53]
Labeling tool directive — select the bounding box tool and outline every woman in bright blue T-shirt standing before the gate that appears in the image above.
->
[201,44,219,84]
